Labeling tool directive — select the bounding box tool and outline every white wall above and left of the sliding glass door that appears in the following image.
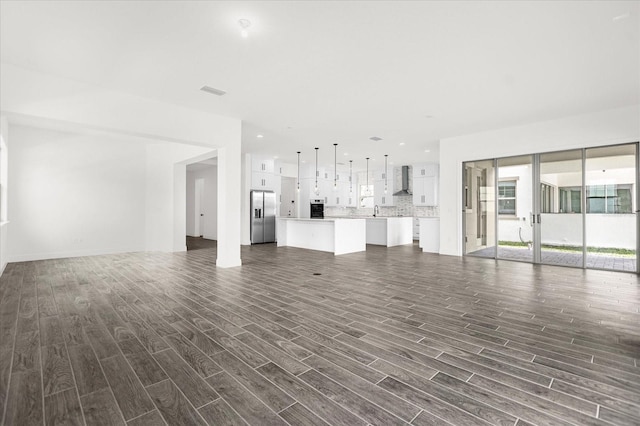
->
[440,105,640,256]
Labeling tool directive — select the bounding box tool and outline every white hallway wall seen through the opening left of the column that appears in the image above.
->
[187,166,218,240]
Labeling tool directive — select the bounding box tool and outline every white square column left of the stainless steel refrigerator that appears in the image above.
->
[216,143,242,268]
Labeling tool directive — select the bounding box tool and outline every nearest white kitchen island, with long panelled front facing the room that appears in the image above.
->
[276,218,367,256]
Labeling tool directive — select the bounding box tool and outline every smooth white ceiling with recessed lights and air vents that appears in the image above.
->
[0,1,640,168]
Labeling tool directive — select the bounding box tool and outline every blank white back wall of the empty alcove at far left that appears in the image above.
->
[8,126,146,262]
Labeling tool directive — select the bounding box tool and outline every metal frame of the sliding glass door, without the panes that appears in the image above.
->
[461,141,640,275]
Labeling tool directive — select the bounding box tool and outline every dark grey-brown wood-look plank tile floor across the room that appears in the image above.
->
[0,240,640,426]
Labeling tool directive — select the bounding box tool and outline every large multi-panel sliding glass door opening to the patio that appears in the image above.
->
[463,143,640,272]
